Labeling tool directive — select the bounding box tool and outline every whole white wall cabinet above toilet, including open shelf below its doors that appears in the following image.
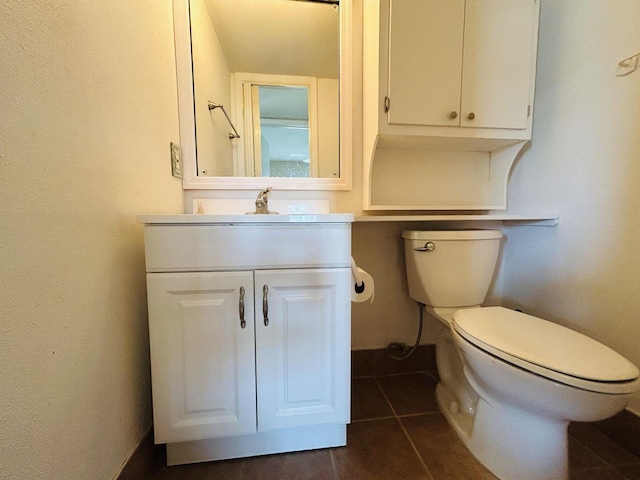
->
[363,0,540,210]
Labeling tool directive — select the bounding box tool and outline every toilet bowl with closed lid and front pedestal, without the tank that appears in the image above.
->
[451,307,640,480]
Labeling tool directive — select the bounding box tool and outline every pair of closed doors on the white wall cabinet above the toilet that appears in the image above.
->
[386,0,535,129]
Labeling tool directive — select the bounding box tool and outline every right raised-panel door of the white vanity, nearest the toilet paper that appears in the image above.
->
[255,268,351,431]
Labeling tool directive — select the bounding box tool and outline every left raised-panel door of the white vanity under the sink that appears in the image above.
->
[147,272,256,443]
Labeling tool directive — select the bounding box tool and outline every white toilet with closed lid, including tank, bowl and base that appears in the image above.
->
[402,230,640,480]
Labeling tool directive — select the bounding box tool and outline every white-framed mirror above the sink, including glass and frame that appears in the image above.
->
[174,0,351,190]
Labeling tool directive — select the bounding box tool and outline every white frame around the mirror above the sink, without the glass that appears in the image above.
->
[173,0,353,190]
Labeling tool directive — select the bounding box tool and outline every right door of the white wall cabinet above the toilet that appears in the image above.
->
[461,0,536,129]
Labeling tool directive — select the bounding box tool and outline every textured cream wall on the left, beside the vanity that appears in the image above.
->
[0,0,183,480]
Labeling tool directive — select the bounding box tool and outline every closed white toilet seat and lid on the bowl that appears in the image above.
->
[452,307,640,394]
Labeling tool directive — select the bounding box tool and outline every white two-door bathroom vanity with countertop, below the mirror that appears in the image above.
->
[138,214,353,465]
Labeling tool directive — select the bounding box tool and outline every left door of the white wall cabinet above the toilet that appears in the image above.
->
[387,0,464,126]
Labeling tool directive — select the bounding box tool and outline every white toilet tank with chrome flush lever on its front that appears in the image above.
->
[402,230,502,307]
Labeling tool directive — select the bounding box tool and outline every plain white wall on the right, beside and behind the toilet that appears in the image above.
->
[503,0,640,413]
